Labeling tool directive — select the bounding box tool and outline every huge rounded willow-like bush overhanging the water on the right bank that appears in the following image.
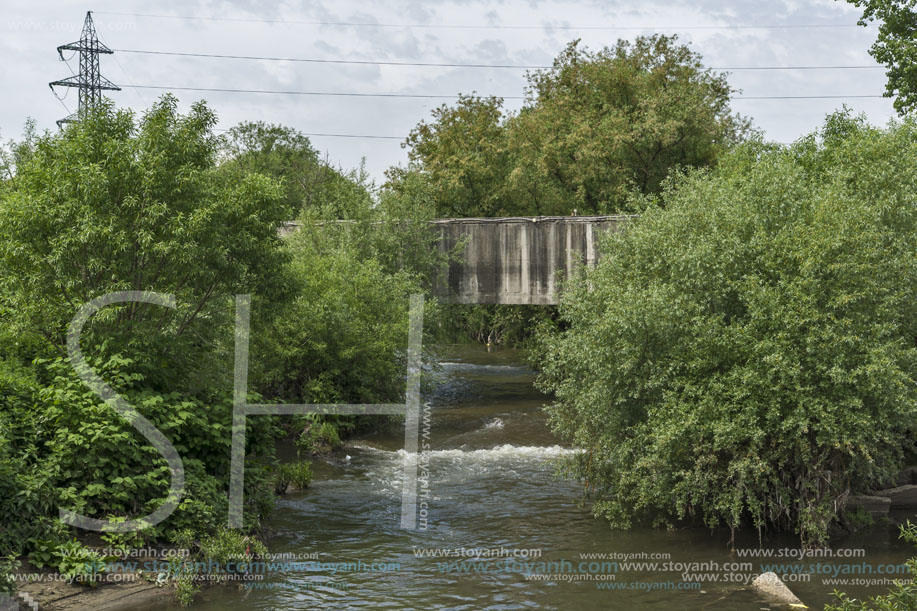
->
[538,113,917,544]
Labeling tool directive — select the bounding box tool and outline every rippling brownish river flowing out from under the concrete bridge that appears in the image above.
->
[157,346,913,611]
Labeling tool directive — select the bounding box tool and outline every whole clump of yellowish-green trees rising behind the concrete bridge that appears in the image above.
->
[389,36,749,217]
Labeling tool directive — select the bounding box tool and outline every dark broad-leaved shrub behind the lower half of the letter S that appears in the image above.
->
[31,356,273,529]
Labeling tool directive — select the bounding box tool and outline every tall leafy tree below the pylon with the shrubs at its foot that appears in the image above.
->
[0,96,289,550]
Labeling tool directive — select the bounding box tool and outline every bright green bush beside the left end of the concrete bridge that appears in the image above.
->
[252,215,433,452]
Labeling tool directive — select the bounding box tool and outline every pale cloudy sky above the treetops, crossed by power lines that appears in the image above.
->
[0,0,894,180]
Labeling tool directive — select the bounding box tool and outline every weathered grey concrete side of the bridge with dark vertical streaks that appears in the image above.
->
[432,216,633,305]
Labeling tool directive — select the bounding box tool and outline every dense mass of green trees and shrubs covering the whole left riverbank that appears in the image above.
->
[0,96,437,589]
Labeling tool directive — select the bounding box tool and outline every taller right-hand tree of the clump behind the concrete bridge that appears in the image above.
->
[508,36,749,215]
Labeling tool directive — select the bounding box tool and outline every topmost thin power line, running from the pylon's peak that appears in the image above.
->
[96,11,860,31]
